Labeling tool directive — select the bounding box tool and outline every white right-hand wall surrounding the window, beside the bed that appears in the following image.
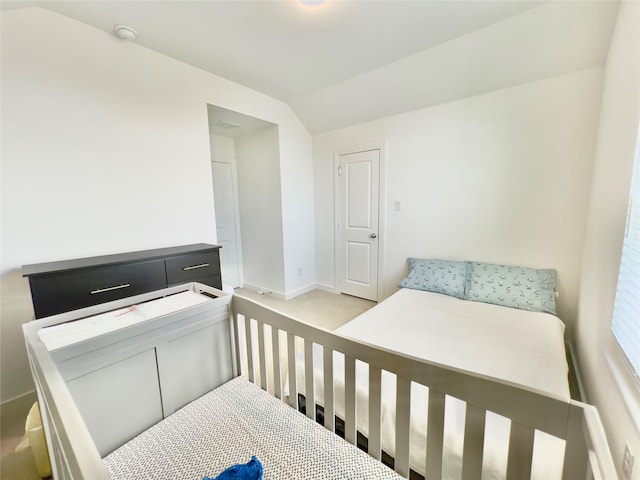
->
[576,2,640,479]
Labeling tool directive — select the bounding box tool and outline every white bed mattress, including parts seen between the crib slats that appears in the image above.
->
[297,289,570,480]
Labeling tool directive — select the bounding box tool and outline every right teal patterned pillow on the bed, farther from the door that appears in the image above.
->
[467,262,556,315]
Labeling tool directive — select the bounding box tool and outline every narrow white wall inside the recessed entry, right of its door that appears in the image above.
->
[236,127,285,296]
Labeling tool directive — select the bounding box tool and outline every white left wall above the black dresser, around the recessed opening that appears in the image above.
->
[0,8,313,401]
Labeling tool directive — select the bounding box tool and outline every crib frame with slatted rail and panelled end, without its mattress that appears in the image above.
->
[24,284,617,480]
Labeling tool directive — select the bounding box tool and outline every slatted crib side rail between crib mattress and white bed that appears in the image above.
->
[232,296,618,480]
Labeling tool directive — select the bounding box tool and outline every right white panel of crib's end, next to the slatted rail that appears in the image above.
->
[156,321,233,417]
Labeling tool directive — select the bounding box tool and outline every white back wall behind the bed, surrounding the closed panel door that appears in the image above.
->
[313,68,602,332]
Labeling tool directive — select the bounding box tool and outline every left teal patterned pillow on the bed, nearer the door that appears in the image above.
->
[399,258,467,298]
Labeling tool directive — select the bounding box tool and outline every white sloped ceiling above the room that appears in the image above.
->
[2,0,618,133]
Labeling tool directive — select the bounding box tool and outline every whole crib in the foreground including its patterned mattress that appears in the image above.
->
[24,284,616,480]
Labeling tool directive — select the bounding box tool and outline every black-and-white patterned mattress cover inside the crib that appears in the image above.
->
[104,377,402,480]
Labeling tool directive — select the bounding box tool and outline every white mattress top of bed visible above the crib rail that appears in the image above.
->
[337,288,570,399]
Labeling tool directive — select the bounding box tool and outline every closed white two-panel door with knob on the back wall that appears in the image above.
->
[339,149,380,301]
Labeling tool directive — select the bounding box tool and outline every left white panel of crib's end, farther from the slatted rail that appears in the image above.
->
[67,349,162,456]
